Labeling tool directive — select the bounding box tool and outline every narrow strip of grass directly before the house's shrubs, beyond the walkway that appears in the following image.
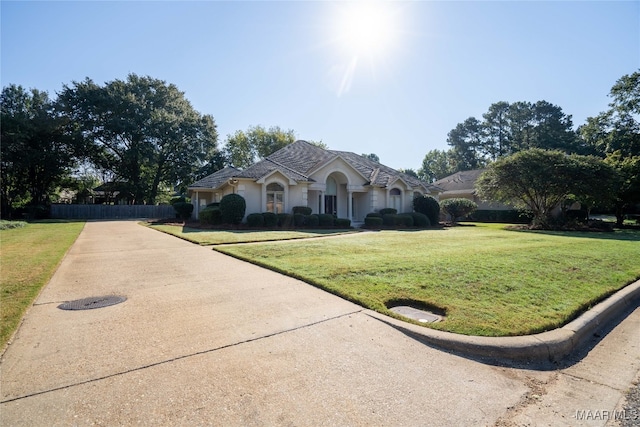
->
[149,225,357,245]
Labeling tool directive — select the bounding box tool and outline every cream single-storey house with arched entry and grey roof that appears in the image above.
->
[188,141,438,222]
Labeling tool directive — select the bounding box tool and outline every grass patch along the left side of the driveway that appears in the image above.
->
[0,221,84,349]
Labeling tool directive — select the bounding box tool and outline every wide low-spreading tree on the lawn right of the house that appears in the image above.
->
[476,148,612,228]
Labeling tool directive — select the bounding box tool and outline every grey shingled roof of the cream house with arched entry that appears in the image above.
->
[189,141,440,190]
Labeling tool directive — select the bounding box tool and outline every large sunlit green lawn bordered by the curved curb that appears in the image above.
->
[215,224,640,336]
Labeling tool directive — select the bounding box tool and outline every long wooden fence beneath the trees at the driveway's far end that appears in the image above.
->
[51,204,176,219]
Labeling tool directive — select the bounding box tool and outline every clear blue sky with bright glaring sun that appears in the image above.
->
[0,0,640,169]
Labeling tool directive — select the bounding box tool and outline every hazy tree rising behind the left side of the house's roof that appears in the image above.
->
[224,126,296,169]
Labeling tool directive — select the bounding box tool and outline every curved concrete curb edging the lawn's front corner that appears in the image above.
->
[365,280,640,362]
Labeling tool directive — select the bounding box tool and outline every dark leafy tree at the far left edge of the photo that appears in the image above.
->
[0,85,81,216]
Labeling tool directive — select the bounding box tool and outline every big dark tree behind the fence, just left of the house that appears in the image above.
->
[58,74,218,204]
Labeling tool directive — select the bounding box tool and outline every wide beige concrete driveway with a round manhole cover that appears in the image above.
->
[0,221,640,426]
